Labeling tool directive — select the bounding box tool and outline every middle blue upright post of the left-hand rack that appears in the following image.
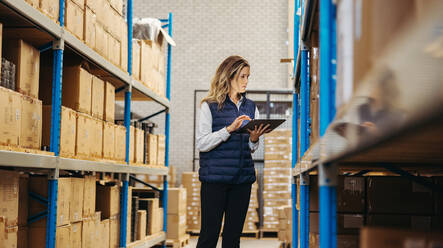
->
[120,0,132,247]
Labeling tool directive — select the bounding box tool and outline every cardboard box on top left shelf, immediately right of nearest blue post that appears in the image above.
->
[65,0,84,40]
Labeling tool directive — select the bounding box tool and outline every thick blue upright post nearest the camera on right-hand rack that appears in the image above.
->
[319,0,338,248]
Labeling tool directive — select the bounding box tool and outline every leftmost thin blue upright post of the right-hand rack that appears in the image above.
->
[291,90,298,248]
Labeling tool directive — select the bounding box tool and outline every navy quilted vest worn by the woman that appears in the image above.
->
[199,97,256,184]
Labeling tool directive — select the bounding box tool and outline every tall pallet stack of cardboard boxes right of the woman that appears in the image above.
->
[263,130,292,232]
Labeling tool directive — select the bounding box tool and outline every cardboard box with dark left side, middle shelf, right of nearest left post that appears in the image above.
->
[62,66,92,114]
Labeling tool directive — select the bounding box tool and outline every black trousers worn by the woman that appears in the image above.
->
[197,183,251,248]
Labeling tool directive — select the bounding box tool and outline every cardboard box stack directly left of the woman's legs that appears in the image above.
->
[182,172,201,232]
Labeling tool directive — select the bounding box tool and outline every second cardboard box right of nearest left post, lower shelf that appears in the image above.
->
[69,177,85,222]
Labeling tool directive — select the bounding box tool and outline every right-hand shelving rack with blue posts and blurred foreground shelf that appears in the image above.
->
[292,0,443,248]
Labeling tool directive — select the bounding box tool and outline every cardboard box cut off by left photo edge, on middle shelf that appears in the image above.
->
[0,87,22,146]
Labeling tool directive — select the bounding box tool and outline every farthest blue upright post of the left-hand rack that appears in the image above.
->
[163,13,172,247]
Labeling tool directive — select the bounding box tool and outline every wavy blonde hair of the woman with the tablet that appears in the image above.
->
[201,55,250,109]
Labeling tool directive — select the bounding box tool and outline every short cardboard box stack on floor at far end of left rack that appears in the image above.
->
[166,188,187,240]
